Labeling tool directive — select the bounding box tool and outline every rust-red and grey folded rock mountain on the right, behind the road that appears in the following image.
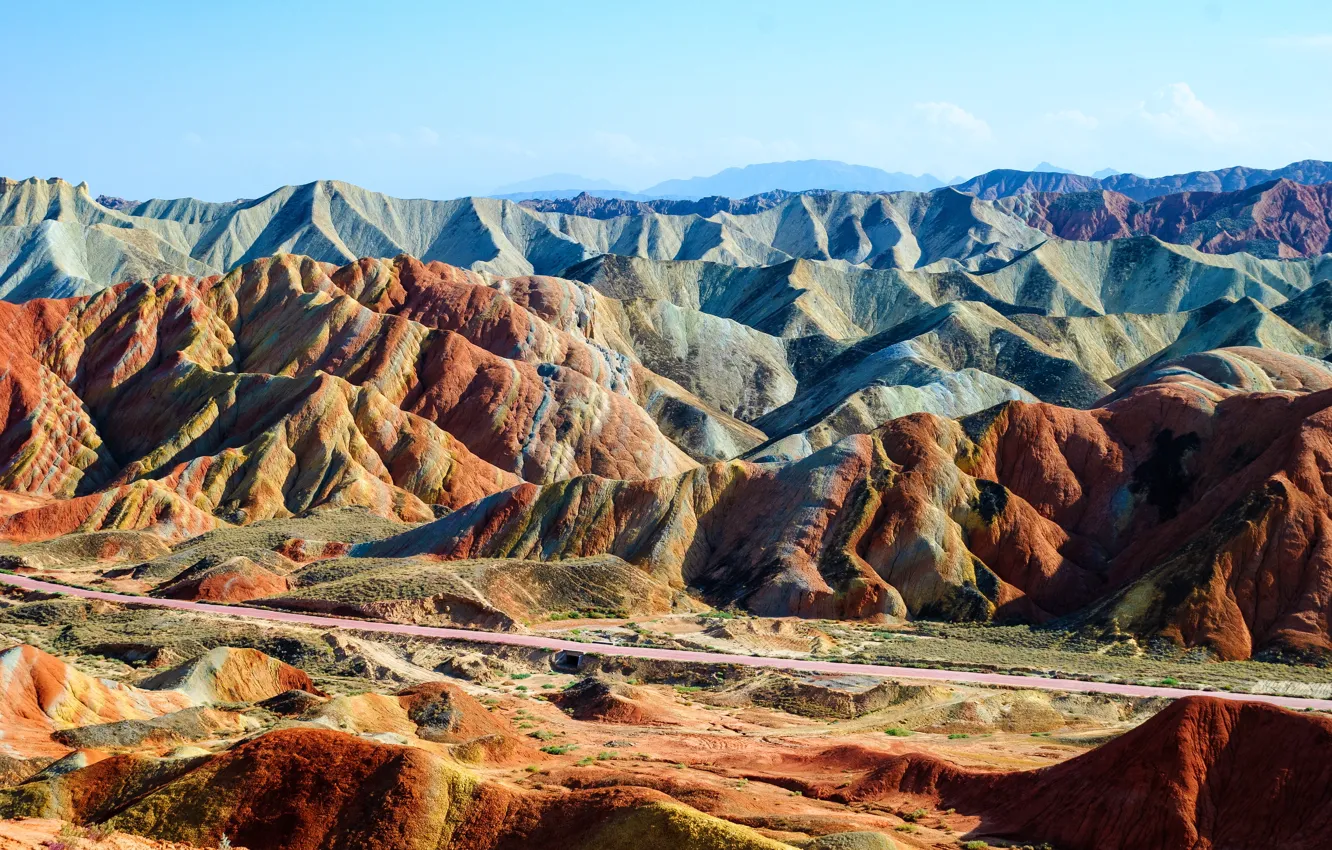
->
[352,365,1332,658]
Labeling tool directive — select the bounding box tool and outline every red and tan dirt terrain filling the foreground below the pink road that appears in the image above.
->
[0,580,1332,850]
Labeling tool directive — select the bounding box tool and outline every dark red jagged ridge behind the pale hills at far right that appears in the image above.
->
[999,180,1332,258]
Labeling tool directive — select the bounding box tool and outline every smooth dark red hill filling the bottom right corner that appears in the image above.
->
[777,697,1332,850]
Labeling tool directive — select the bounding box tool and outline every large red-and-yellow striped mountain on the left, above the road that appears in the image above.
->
[0,257,762,538]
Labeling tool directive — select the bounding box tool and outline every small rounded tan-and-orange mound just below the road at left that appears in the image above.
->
[140,646,321,703]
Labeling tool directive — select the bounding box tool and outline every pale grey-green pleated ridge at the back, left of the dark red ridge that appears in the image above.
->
[0,179,1044,301]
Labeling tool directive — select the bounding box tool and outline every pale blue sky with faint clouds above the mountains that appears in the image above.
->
[0,0,1332,200]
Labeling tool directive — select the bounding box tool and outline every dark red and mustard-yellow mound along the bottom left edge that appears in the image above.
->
[0,729,786,850]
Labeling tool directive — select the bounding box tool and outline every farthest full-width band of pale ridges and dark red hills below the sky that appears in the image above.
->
[12,164,1332,300]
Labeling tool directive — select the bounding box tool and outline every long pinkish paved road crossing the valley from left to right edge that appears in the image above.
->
[0,573,1332,710]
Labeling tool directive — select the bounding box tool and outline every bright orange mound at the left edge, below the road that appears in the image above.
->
[0,645,193,758]
